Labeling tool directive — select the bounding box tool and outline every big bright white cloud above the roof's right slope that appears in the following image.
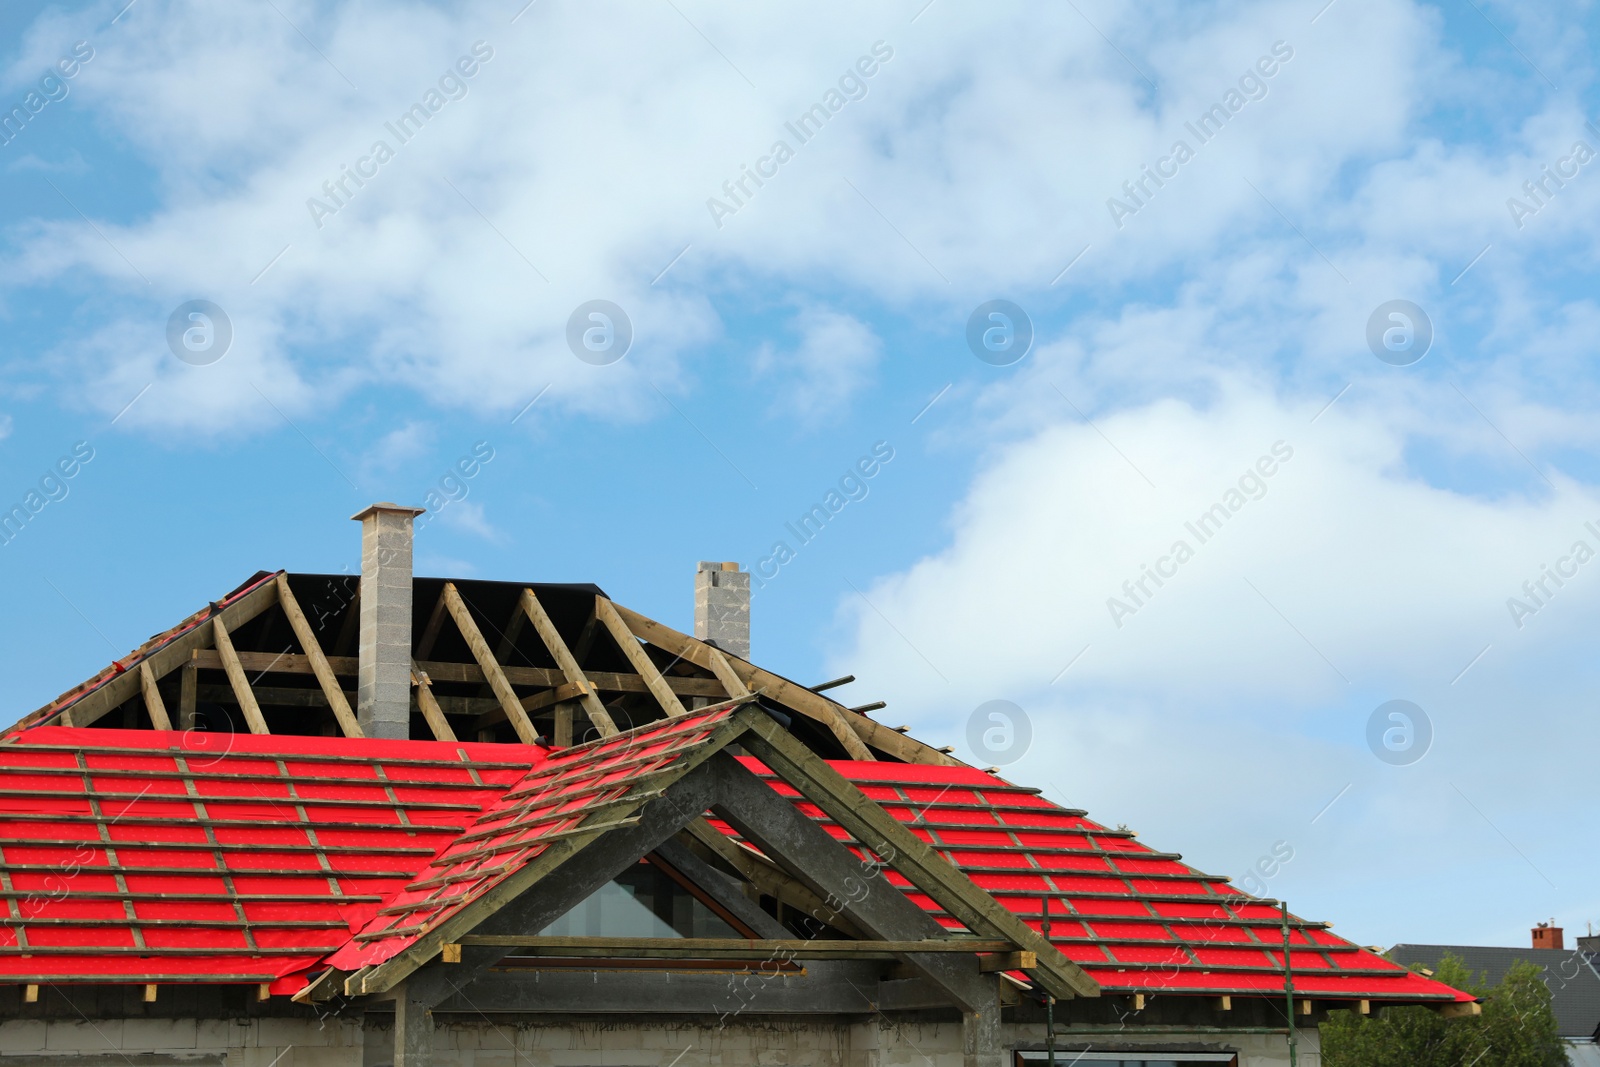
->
[830,379,1600,942]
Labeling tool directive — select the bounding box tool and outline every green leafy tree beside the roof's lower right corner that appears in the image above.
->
[1320,955,1566,1067]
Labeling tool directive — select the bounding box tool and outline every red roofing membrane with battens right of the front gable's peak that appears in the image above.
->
[720,758,1474,1001]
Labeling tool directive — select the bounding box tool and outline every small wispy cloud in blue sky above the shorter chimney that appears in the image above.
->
[755,307,883,421]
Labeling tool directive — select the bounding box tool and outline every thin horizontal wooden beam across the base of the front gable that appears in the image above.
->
[444,934,1016,969]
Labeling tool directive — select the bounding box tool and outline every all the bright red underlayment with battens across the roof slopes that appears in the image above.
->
[0,710,1472,1001]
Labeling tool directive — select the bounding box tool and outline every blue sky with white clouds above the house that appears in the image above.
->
[0,0,1600,945]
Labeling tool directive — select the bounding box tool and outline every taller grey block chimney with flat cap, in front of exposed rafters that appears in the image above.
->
[350,502,426,739]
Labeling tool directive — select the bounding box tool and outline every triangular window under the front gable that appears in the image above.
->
[539,862,742,937]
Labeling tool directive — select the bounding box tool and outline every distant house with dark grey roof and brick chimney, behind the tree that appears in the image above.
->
[1387,923,1600,1067]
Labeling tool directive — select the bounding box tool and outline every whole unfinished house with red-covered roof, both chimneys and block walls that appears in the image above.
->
[0,504,1477,1067]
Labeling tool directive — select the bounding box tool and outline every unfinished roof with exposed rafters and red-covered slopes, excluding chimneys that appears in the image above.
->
[0,571,1472,1005]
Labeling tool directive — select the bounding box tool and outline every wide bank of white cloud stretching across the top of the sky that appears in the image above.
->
[8,0,1548,429]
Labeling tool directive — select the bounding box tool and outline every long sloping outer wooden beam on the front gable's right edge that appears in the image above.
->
[739,715,1099,998]
